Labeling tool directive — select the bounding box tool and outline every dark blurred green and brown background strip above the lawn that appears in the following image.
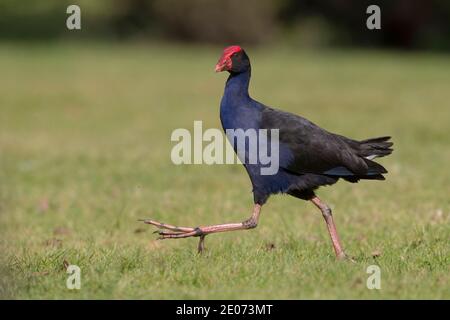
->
[0,0,450,50]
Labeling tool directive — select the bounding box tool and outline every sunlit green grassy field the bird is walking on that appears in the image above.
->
[0,44,450,299]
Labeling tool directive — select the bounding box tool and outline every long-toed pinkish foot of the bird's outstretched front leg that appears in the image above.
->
[140,220,206,253]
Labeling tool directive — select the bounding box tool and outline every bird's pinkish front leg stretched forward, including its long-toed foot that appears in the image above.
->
[143,204,261,252]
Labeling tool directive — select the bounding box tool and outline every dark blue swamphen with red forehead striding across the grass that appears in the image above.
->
[143,45,393,260]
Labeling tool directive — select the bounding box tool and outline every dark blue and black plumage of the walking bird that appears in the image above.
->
[220,49,392,204]
